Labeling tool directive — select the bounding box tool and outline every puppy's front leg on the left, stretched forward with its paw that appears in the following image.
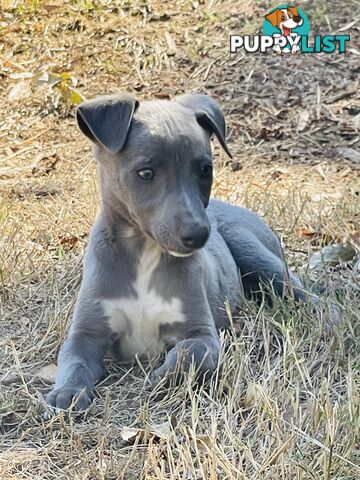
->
[46,299,109,410]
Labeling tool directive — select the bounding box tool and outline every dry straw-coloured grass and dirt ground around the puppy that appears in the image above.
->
[0,0,360,480]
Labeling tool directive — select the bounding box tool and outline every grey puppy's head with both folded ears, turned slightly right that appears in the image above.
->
[77,94,231,256]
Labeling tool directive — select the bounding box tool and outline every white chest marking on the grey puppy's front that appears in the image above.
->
[103,243,185,359]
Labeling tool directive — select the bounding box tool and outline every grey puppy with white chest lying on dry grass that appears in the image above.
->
[47,94,305,410]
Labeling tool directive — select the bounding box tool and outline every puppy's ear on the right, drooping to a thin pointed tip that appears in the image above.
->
[175,94,232,158]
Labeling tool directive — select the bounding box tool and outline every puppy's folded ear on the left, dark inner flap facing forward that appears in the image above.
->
[76,94,139,154]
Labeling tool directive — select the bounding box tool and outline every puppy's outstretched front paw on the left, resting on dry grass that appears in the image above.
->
[46,386,92,412]
